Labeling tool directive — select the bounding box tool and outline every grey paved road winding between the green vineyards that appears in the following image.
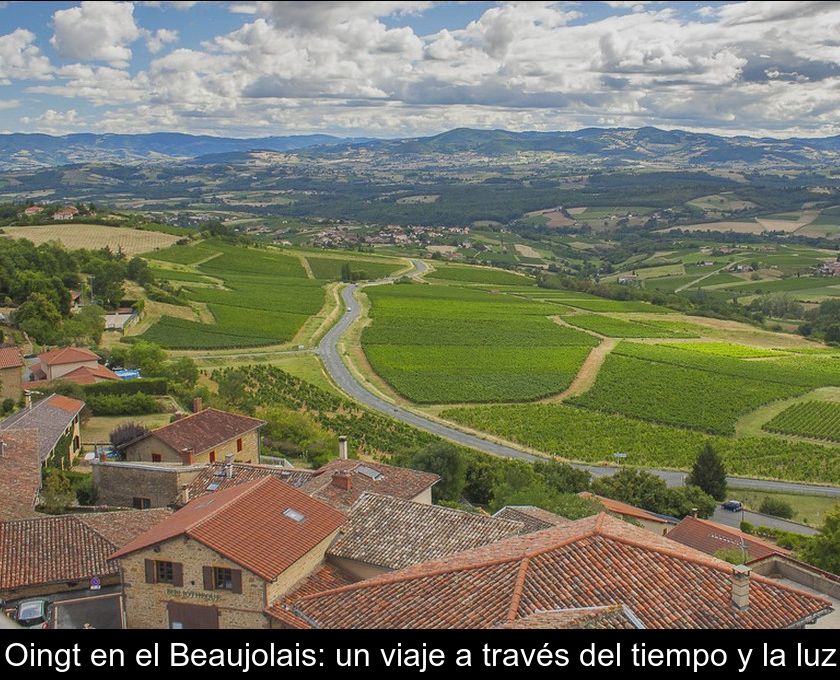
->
[318,259,840,498]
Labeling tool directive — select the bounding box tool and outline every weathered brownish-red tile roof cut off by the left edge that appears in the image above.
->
[0,430,41,520]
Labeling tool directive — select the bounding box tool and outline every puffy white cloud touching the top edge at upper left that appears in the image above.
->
[50,1,141,66]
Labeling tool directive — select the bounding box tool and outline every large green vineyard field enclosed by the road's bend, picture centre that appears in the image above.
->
[362,285,597,404]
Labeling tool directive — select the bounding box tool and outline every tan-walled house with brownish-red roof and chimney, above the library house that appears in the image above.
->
[122,399,265,465]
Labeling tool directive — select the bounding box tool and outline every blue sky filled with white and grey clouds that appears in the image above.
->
[0,0,840,137]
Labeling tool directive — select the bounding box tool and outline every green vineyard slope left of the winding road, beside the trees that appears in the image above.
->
[140,242,324,349]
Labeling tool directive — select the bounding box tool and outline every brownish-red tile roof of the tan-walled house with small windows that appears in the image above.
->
[126,408,265,454]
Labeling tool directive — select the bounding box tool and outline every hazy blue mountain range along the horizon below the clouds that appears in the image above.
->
[0,127,840,171]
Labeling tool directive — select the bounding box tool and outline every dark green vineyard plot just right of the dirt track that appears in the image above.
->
[573,354,807,434]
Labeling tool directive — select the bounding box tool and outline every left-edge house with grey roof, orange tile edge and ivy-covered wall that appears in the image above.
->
[0,394,85,469]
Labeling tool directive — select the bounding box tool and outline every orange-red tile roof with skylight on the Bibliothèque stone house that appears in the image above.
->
[111,477,347,581]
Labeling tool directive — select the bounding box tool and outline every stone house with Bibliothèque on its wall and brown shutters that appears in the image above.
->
[111,477,346,628]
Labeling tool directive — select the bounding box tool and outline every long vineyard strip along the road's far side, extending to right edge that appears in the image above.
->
[441,404,840,484]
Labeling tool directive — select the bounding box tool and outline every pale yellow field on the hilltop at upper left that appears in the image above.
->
[4,224,179,256]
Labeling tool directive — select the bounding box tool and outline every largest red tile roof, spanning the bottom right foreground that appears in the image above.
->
[278,513,830,628]
